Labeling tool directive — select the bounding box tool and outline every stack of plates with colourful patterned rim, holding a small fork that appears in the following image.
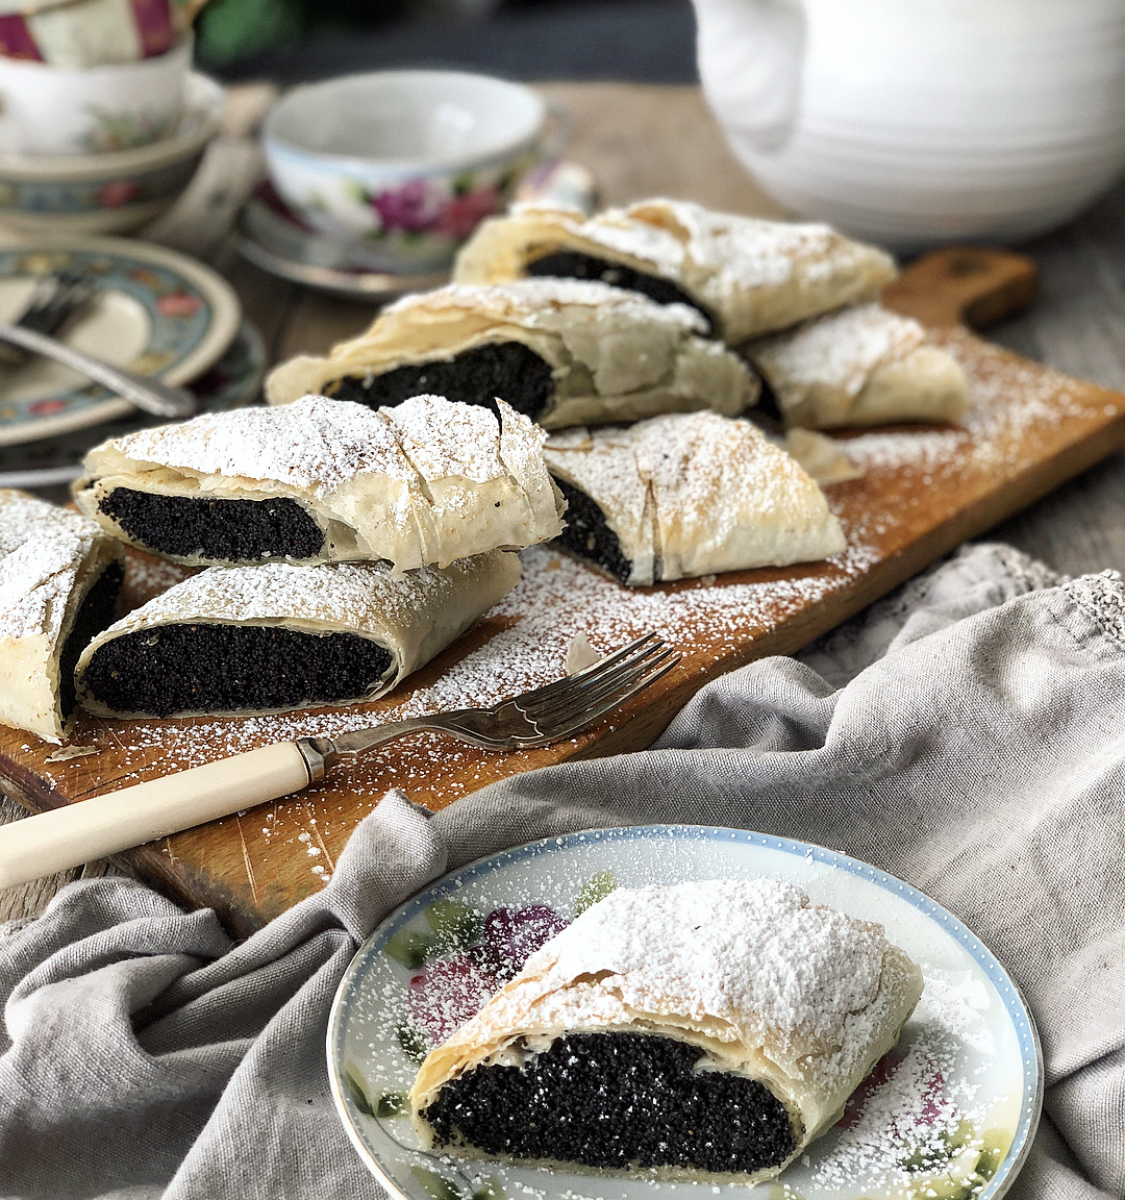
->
[0,236,266,487]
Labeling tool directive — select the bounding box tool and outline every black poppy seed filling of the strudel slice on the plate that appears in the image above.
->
[422,1033,796,1174]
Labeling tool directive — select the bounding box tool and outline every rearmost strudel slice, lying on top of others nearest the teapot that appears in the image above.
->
[453,199,895,346]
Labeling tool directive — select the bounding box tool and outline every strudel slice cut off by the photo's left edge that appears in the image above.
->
[0,490,124,742]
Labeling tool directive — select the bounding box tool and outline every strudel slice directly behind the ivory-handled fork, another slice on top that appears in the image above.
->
[78,551,519,716]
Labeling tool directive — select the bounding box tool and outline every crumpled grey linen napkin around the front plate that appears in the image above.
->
[0,545,1125,1200]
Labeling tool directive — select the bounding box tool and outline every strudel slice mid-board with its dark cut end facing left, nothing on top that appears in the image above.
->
[543,413,844,584]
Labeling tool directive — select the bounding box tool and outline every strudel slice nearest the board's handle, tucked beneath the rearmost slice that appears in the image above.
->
[744,304,969,430]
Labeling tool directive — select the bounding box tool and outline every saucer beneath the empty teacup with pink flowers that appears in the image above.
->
[239,162,596,304]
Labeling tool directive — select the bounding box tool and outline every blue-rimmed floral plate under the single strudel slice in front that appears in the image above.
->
[327,826,1042,1200]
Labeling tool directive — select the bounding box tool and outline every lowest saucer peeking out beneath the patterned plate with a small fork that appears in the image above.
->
[0,322,267,488]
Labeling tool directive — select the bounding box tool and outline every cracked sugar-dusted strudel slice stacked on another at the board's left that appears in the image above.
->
[74,396,563,570]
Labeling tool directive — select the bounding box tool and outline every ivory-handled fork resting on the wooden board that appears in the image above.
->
[0,634,680,888]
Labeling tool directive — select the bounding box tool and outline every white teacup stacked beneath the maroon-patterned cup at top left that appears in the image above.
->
[0,37,192,155]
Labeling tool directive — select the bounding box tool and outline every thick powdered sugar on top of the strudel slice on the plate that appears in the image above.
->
[524,880,906,1054]
